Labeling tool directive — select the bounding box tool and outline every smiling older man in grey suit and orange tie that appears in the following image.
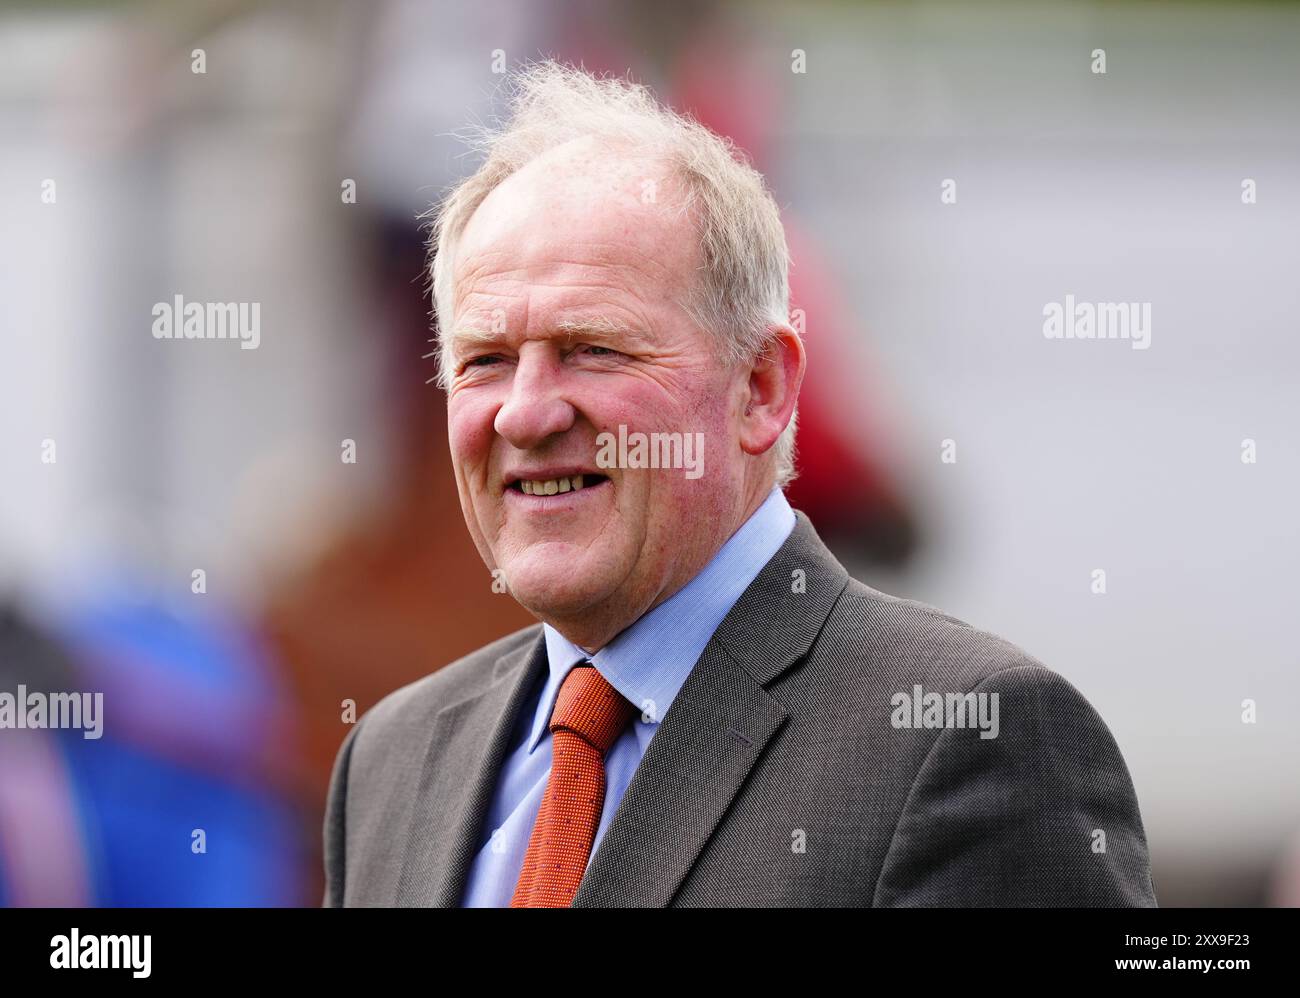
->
[325,62,1154,907]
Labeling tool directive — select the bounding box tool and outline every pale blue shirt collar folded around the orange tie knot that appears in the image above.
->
[528,489,794,752]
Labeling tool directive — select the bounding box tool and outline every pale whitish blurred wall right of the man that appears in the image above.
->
[777,4,1300,888]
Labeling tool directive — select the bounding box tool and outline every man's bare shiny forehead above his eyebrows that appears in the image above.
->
[452,140,699,312]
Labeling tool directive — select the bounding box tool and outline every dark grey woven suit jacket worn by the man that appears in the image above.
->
[324,512,1156,907]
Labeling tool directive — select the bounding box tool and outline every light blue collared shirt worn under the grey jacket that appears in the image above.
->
[462,489,794,908]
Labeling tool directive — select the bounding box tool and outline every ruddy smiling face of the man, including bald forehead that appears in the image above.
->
[443,143,746,647]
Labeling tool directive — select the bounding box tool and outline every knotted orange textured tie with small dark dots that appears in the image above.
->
[510,664,637,908]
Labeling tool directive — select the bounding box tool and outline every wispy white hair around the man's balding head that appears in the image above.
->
[425,60,798,487]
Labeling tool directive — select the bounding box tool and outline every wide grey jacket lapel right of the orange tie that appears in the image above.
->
[573,511,848,907]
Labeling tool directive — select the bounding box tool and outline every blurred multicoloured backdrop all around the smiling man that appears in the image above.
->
[0,0,1300,906]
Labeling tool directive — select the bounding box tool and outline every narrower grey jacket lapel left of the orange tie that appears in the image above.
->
[395,628,546,908]
